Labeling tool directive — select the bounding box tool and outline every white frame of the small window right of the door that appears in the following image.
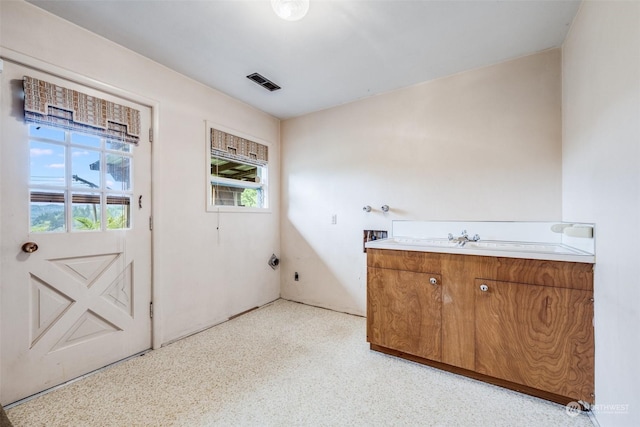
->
[204,121,273,213]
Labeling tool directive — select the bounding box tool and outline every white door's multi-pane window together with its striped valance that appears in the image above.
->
[23,76,141,233]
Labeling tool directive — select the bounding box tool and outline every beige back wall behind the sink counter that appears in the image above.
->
[281,49,561,314]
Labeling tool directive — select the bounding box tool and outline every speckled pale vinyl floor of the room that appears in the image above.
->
[7,300,592,427]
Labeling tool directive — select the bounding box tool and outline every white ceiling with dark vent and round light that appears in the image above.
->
[29,0,580,119]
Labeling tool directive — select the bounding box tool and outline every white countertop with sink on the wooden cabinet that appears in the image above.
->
[365,237,595,264]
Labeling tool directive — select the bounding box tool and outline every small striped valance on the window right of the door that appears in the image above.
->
[211,128,269,166]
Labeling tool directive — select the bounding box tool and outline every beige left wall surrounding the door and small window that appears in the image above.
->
[0,1,280,343]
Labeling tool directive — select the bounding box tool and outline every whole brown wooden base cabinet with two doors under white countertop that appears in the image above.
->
[367,248,594,404]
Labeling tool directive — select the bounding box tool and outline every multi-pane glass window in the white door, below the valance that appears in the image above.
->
[29,124,134,233]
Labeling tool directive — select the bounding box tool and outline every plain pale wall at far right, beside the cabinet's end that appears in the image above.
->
[562,1,640,427]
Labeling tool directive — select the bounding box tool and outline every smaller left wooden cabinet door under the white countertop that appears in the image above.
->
[367,268,442,361]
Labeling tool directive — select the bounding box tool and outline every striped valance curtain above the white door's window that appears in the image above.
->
[23,76,140,144]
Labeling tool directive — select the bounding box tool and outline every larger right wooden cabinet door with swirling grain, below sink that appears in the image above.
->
[475,279,594,402]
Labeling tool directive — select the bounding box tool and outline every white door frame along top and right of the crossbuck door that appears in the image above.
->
[0,47,163,392]
